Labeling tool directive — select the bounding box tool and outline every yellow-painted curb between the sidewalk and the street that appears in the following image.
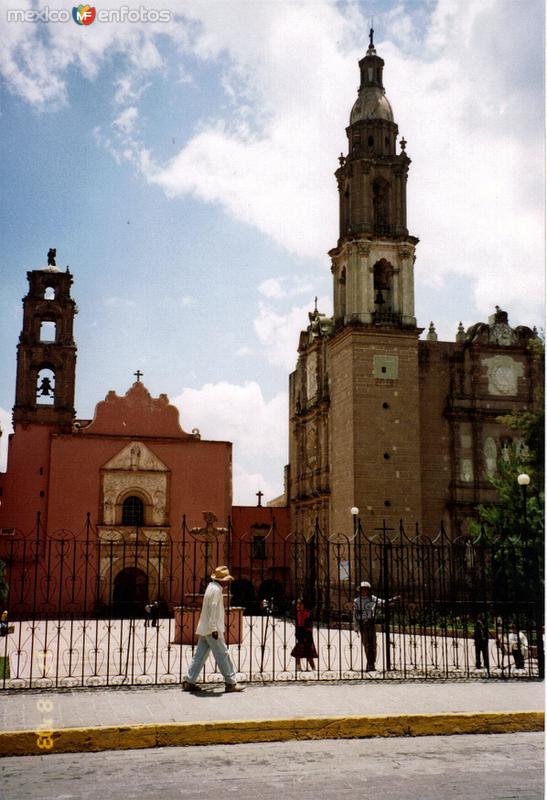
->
[0,711,545,756]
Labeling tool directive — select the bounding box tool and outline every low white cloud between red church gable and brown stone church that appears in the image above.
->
[171,381,288,504]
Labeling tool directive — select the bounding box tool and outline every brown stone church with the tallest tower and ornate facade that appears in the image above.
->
[288,31,541,536]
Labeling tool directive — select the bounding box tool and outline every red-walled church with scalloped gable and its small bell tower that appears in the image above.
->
[0,266,289,613]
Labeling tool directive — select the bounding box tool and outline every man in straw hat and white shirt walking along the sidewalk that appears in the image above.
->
[182,566,243,692]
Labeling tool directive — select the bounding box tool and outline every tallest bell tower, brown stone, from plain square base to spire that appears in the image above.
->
[328,30,421,532]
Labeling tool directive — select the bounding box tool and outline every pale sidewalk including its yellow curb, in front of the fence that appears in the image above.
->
[0,680,545,756]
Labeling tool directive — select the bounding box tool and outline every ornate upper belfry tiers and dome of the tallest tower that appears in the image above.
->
[330,29,418,328]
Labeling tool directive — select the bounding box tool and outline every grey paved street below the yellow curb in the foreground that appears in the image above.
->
[0,733,544,800]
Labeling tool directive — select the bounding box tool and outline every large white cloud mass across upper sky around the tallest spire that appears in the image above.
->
[0,0,544,318]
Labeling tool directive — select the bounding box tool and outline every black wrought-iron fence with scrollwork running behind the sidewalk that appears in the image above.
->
[0,516,544,688]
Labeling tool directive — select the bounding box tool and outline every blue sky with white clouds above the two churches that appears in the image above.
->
[0,0,545,504]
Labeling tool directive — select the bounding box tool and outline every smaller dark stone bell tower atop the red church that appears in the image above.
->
[13,250,76,430]
